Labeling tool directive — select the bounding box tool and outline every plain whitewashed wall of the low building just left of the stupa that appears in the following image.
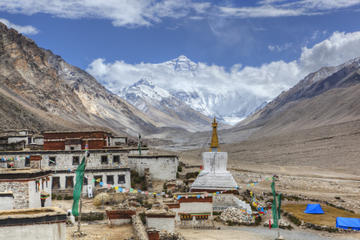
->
[128,155,179,180]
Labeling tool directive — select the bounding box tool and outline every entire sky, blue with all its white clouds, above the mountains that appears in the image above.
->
[0,0,360,103]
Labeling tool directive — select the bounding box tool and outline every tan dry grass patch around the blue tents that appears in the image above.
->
[283,203,360,227]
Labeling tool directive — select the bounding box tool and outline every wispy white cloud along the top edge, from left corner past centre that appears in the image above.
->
[0,0,210,27]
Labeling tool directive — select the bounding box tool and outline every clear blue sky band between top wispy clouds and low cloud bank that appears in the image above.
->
[0,0,360,69]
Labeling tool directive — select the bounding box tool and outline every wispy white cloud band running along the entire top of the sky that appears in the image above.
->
[0,0,360,27]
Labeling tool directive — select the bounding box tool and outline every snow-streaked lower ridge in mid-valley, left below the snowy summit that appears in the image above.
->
[119,79,211,132]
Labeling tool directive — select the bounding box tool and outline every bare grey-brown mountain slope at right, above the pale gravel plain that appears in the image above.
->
[234,58,360,136]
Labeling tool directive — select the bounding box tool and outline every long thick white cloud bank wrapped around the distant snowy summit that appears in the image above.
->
[87,32,360,103]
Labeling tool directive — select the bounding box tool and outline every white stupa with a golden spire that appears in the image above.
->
[190,118,238,192]
